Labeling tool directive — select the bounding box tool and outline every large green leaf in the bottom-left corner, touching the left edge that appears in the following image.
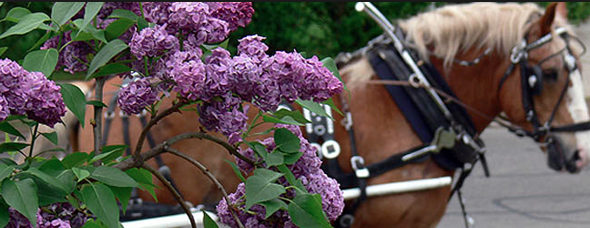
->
[2,179,39,224]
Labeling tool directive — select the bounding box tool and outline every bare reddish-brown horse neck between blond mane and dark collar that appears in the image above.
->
[431,51,508,132]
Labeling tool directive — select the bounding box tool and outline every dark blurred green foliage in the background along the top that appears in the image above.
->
[0,2,590,60]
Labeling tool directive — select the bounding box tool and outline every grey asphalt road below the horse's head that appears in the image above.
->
[437,127,590,228]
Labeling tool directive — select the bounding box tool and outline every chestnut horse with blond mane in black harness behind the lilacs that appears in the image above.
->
[70,3,590,228]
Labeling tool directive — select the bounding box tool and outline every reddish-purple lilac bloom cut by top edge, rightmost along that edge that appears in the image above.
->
[207,2,254,32]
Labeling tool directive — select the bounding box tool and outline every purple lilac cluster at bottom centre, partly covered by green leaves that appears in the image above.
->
[217,124,344,227]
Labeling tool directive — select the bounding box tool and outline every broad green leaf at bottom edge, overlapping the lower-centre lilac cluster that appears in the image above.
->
[288,194,332,228]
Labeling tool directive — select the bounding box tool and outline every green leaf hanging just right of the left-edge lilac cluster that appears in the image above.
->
[58,83,86,127]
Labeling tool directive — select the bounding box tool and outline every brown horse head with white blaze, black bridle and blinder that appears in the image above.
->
[498,3,590,173]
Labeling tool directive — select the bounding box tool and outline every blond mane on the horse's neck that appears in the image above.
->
[399,2,544,67]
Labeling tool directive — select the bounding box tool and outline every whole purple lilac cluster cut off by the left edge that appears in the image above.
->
[0,59,66,127]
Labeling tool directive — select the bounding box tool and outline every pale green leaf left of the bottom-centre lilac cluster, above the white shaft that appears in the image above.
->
[246,168,285,210]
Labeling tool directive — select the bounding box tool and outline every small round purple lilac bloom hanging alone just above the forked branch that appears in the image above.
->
[117,78,158,115]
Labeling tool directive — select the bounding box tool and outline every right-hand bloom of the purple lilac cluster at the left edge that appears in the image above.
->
[23,72,66,127]
